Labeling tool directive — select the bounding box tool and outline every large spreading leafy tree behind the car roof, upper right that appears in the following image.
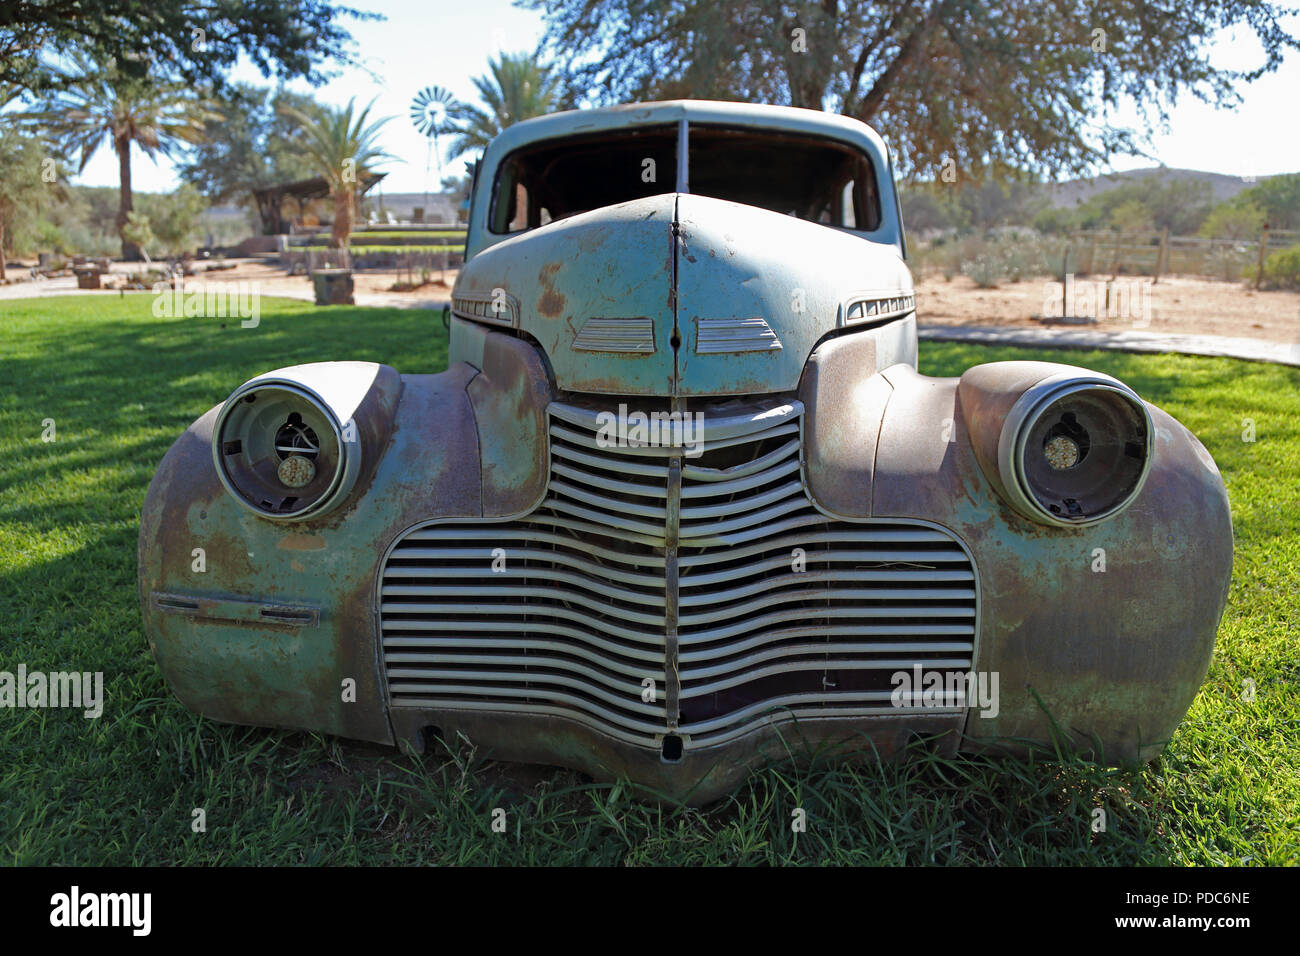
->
[523,0,1300,176]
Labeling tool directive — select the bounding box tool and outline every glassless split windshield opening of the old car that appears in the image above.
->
[489,125,880,235]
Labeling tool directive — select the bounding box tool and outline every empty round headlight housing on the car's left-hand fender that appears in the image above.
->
[212,378,361,522]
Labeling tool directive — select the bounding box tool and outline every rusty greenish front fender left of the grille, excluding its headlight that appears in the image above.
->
[139,336,547,743]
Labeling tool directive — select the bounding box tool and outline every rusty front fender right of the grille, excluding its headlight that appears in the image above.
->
[801,346,1232,761]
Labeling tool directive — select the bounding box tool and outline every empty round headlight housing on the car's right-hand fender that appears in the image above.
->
[997,373,1153,527]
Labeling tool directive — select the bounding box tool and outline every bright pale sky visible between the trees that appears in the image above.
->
[68,0,1300,193]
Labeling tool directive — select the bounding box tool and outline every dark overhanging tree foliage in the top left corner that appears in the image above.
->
[0,0,382,90]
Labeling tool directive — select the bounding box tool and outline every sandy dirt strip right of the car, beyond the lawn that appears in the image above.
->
[917,276,1300,342]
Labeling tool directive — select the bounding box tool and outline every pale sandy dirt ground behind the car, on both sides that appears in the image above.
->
[0,260,1300,342]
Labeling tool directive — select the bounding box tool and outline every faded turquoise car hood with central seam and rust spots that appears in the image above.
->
[452,194,914,397]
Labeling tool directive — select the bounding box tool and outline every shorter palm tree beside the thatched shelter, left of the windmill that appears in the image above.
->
[282,100,393,248]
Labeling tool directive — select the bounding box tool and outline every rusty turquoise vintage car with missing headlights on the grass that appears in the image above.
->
[139,101,1232,803]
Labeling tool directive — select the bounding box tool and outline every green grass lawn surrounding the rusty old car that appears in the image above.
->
[0,295,1300,865]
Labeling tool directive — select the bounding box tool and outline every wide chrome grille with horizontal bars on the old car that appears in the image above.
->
[380,399,976,747]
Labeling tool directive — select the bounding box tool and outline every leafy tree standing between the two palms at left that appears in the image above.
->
[177,83,320,206]
